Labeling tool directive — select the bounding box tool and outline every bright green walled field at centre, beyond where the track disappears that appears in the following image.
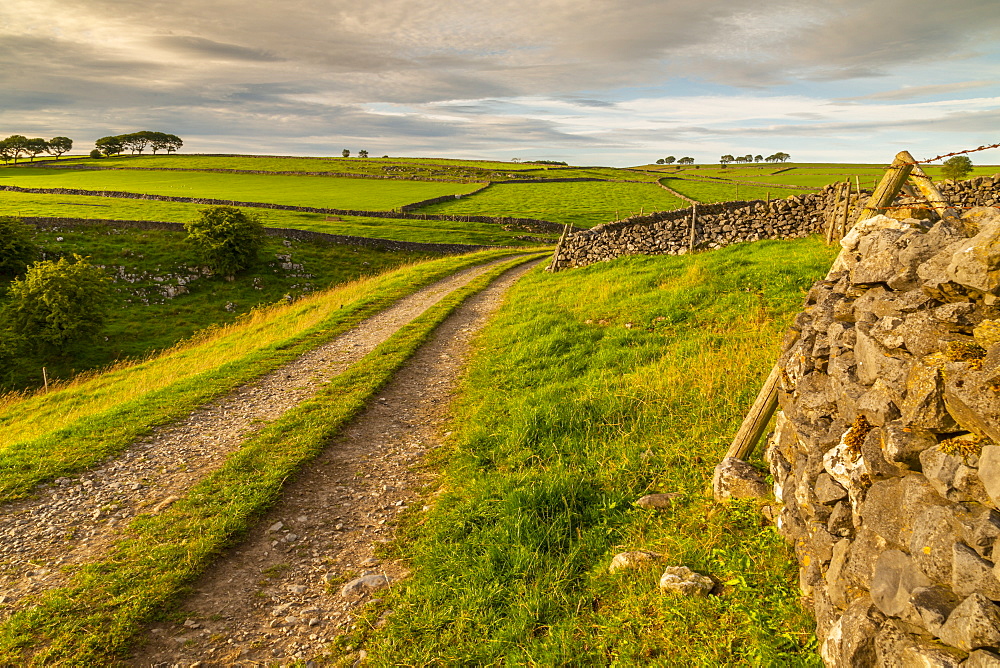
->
[420,182,688,227]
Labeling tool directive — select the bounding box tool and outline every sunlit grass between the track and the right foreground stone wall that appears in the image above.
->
[356,238,832,666]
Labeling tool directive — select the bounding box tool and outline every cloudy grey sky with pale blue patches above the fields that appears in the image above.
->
[0,0,1000,166]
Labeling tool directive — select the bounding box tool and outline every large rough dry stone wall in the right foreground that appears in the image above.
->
[766,200,1000,668]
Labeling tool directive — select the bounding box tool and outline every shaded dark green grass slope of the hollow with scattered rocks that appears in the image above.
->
[0,225,440,390]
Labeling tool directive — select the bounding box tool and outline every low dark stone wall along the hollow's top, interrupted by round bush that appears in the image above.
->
[21,216,509,254]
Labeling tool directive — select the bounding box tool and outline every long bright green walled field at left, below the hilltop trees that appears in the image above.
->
[0,167,480,211]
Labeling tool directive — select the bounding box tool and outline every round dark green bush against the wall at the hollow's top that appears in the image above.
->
[184,206,264,276]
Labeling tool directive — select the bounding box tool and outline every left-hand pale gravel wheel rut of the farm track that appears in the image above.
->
[0,253,540,620]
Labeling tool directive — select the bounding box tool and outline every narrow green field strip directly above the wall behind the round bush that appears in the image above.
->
[0,191,555,246]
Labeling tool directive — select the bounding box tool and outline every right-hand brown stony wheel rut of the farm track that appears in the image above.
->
[129,262,537,667]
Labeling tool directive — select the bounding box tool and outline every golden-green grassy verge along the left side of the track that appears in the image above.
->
[0,251,536,502]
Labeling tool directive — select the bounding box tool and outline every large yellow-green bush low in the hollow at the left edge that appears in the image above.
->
[3,254,111,353]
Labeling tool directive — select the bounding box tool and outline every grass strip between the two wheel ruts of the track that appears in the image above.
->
[0,253,548,665]
